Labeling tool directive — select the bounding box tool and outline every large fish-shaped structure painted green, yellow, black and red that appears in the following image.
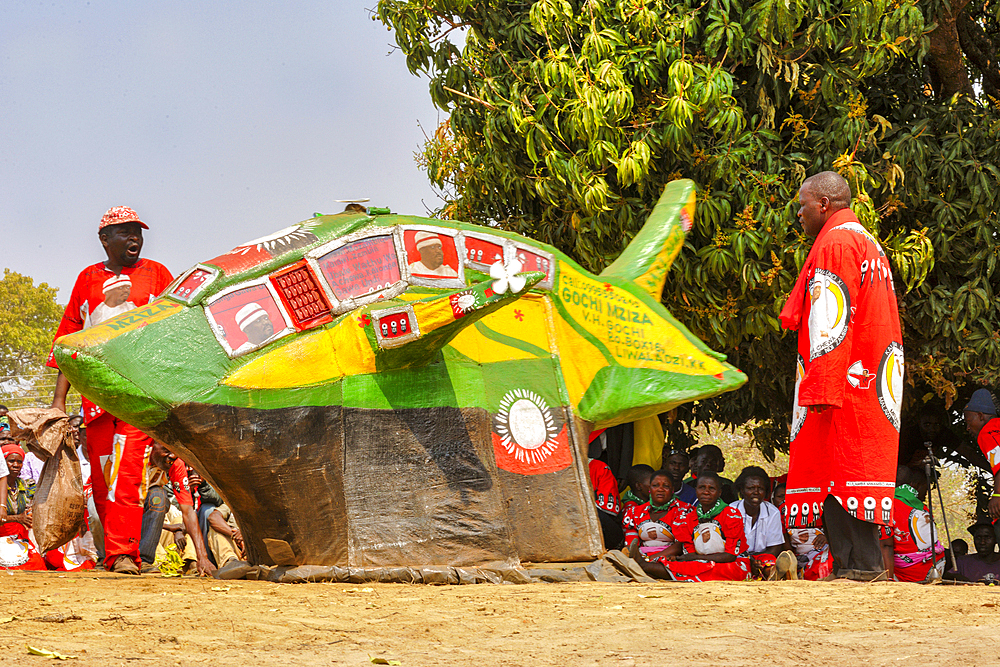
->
[55,180,746,568]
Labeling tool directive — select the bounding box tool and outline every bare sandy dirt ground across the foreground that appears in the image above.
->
[0,572,1000,667]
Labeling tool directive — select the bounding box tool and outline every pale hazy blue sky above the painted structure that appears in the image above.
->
[0,0,443,303]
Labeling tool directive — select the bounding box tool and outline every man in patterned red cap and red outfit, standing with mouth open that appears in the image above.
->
[48,206,173,574]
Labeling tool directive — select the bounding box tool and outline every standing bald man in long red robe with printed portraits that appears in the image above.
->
[781,171,903,571]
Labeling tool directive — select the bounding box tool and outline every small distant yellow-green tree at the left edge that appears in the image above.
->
[0,269,63,380]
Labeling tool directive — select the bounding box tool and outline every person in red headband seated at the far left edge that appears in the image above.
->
[0,441,46,570]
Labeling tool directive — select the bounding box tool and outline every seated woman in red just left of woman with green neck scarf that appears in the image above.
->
[623,470,697,579]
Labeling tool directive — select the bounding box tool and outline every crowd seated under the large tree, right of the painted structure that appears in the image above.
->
[591,445,976,583]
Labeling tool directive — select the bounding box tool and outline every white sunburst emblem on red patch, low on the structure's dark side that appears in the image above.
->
[496,389,559,464]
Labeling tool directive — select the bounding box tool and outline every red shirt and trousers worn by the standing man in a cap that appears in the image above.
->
[47,239,173,567]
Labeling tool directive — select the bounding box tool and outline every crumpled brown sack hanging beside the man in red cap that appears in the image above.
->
[8,408,87,553]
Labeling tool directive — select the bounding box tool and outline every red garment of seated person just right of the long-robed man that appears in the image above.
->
[891,484,944,583]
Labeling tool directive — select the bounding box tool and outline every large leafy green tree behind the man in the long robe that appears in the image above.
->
[377,0,1000,452]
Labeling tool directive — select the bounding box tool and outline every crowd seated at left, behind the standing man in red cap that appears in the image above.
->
[0,406,250,578]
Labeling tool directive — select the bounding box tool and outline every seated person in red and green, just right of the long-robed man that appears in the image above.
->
[886,465,944,583]
